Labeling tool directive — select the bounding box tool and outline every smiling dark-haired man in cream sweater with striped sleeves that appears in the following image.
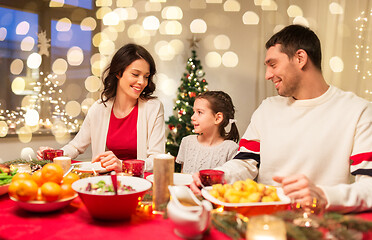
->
[191,25,372,212]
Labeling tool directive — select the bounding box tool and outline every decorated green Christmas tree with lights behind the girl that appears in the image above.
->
[166,45,208,171]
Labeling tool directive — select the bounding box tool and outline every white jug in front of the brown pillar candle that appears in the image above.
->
[167,186,213,239]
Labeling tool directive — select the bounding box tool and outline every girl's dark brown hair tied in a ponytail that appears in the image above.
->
[196,91,239,142]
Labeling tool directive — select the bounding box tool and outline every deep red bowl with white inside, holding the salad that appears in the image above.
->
[72,176,152,220]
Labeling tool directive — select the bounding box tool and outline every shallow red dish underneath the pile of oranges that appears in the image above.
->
[10,193,78,212]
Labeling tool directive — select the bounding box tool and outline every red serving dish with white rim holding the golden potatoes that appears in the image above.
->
[201,187,291,216]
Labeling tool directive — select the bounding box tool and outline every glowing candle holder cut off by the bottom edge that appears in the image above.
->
[246,215,287,240]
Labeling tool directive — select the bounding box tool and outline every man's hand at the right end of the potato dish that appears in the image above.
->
[273,174,327,205]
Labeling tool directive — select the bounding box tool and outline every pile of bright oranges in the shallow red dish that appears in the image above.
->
[8,163,79,202]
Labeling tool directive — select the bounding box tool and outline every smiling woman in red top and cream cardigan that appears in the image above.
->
[38,44,165,172]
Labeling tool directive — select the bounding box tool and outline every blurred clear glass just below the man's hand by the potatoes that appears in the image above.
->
[291,198,325,228]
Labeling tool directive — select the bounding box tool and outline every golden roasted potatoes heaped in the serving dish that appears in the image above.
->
[209,179,280,203]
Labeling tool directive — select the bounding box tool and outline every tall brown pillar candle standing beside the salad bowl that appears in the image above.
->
[153,154,174,211]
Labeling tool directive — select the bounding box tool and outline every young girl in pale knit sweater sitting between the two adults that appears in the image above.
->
[176,91,239,173]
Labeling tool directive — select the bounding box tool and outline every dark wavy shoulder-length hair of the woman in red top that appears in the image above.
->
[101,43,156,103]
